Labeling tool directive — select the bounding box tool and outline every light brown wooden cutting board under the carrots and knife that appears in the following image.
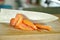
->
[0,21,60,40]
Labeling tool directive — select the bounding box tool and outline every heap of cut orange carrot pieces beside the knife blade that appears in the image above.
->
[10,14,51,31]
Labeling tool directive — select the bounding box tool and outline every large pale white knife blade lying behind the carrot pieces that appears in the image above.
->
[0,9,58,23]
